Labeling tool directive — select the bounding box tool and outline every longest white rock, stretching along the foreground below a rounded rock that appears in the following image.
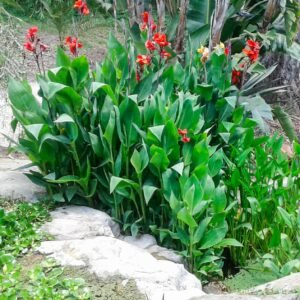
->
[38,236,201,300]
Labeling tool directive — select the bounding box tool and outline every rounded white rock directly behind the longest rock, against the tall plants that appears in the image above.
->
[41,206,120,240]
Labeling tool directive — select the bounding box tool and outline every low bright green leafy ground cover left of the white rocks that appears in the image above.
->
[0,203,90,300]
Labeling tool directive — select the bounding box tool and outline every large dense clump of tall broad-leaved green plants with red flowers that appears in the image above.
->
[9,4,300,284]
